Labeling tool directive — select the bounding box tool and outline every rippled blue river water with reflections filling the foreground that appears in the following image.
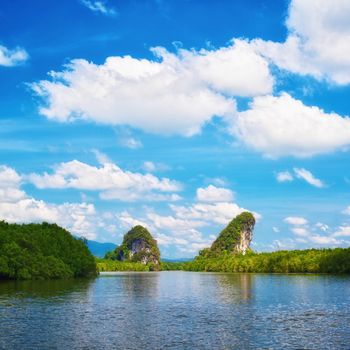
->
[0,272,350,350]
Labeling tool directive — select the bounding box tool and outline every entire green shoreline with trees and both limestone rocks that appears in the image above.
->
[0,217,350,281]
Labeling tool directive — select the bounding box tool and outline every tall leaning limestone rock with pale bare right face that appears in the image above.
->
[201,212,255,256]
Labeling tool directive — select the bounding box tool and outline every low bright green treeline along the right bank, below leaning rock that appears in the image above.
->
[166,248,350,273]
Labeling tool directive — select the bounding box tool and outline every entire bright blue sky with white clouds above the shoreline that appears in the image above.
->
[0,0,350,258]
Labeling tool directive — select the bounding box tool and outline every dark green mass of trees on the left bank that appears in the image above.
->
[0,221,97,279]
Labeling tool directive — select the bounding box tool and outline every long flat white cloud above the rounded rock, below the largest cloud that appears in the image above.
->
[26,159,182,201]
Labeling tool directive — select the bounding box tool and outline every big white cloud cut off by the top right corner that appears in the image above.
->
[252,0,350,85]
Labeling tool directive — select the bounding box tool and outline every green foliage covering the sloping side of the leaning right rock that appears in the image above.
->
[199,212,255,257]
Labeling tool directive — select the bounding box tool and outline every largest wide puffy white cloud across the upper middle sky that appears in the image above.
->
[32,40,273,136]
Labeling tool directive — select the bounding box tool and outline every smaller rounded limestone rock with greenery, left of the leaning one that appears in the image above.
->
[115,225,160,270]
